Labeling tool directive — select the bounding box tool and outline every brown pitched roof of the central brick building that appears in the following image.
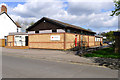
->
[26,17,95,34]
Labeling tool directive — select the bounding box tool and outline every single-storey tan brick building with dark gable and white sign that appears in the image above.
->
[8,17,103,49]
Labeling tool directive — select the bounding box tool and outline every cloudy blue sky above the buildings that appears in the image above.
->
[0,0,118,33]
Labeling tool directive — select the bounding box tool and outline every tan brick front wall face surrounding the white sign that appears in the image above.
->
[28,33,64,49]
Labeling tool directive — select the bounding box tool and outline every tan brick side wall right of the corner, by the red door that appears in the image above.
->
[65,33,95,49]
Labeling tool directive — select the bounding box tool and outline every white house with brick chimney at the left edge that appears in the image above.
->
[0,5,21,39]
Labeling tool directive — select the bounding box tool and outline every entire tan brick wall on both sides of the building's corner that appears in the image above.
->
[28,33,100,49]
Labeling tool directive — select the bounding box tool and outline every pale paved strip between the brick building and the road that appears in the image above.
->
[2,48,97,65]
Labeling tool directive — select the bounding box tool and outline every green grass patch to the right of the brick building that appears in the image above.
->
[84,48,120,58]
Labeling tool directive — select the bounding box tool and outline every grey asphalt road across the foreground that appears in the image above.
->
[2,55,118,78]
